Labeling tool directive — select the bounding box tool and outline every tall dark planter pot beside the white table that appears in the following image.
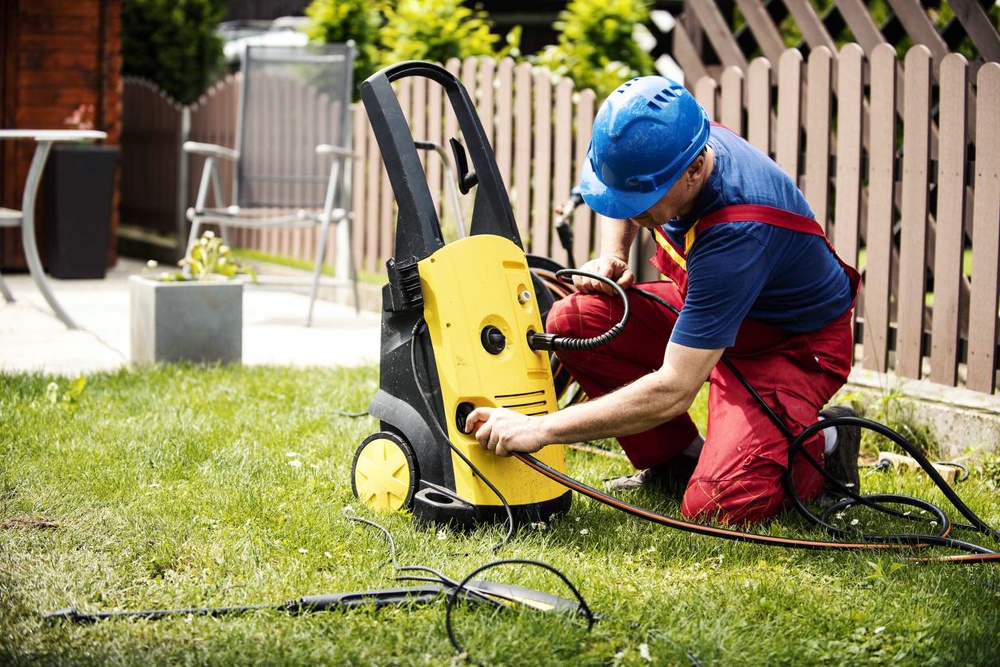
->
[45,144,118,279]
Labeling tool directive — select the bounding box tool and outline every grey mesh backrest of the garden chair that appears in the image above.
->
[236,43,354,208]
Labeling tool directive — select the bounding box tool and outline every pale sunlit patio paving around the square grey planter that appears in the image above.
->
[0,258,380,376]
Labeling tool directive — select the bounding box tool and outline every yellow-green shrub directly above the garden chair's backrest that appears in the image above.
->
[306,0,385,95]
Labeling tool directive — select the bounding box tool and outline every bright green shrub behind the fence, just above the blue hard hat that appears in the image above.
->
[532,0,654,100]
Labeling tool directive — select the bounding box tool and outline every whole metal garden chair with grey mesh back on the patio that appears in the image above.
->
[184,42,358,326]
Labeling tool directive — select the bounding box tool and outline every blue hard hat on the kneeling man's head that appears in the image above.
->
[580,76,711,219]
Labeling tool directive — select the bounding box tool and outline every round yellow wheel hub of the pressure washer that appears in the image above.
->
[354,438,412,513]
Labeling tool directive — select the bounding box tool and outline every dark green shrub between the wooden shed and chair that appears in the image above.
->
[122,0,226,104]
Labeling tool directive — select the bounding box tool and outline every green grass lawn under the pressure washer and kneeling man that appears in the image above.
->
[0,366,1000,666]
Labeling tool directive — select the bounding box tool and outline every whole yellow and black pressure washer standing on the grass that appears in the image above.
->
[351,61,571,527]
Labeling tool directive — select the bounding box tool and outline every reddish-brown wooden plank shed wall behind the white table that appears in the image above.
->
[0,0,121,269]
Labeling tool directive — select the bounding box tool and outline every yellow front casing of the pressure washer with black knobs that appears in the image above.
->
[418,234,566,506]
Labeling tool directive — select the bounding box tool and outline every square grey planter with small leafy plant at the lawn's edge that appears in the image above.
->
[129,231,256,364]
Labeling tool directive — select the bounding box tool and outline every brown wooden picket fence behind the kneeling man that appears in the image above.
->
[122,44,1000,393]
